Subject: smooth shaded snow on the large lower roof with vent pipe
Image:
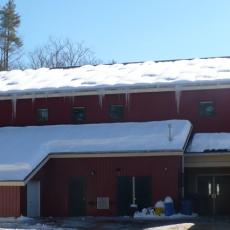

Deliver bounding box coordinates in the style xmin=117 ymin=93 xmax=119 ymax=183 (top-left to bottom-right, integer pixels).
xmin=0 ymin=120 xmax=191 ymax=181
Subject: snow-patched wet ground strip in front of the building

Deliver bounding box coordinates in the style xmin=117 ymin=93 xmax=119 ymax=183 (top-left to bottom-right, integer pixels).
xmin=3 ymin=216 xmax=230 ymax=230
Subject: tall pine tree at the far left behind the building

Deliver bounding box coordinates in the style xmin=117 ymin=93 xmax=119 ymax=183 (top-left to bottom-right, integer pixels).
xmin=0 ymin=0 xmax=22 ymax=70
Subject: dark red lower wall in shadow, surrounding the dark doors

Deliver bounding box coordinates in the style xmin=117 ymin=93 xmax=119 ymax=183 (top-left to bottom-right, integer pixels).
xmin=34 ymin=156 xmax=180 ymax=216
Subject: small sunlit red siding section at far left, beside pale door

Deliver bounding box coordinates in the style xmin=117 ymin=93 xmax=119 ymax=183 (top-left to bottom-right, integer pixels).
xmin=0 ymin=186 xmax=23 ymax=217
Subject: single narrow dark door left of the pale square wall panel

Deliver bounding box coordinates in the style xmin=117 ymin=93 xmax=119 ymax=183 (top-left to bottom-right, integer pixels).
xmin=69 ymin=177 xmax=86 ymax=216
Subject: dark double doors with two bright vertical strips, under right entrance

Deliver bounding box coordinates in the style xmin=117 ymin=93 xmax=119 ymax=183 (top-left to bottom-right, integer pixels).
xmin=197 ymin=175 xmax=230 ymax=215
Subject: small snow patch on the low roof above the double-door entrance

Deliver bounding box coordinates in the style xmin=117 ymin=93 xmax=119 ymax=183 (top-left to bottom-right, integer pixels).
xmin=186 ymin=133 xmax=230 ymax=153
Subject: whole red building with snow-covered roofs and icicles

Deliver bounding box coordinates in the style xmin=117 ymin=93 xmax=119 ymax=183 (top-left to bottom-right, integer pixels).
xmin=0 ymin=58 xmax=230 ymax=216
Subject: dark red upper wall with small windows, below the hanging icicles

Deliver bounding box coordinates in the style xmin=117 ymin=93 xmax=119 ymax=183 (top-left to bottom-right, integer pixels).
xmin=0 ymin=89 xmax=230 ymax=132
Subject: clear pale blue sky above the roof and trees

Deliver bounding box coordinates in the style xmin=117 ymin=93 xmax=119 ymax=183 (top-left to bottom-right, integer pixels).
xmin=0 ymin=0 xmax=230 ymax=62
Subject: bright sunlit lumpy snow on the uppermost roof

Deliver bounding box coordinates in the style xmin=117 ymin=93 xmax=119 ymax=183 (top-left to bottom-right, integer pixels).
xmin=0 ymin=58 xmax=230 ymax=94
